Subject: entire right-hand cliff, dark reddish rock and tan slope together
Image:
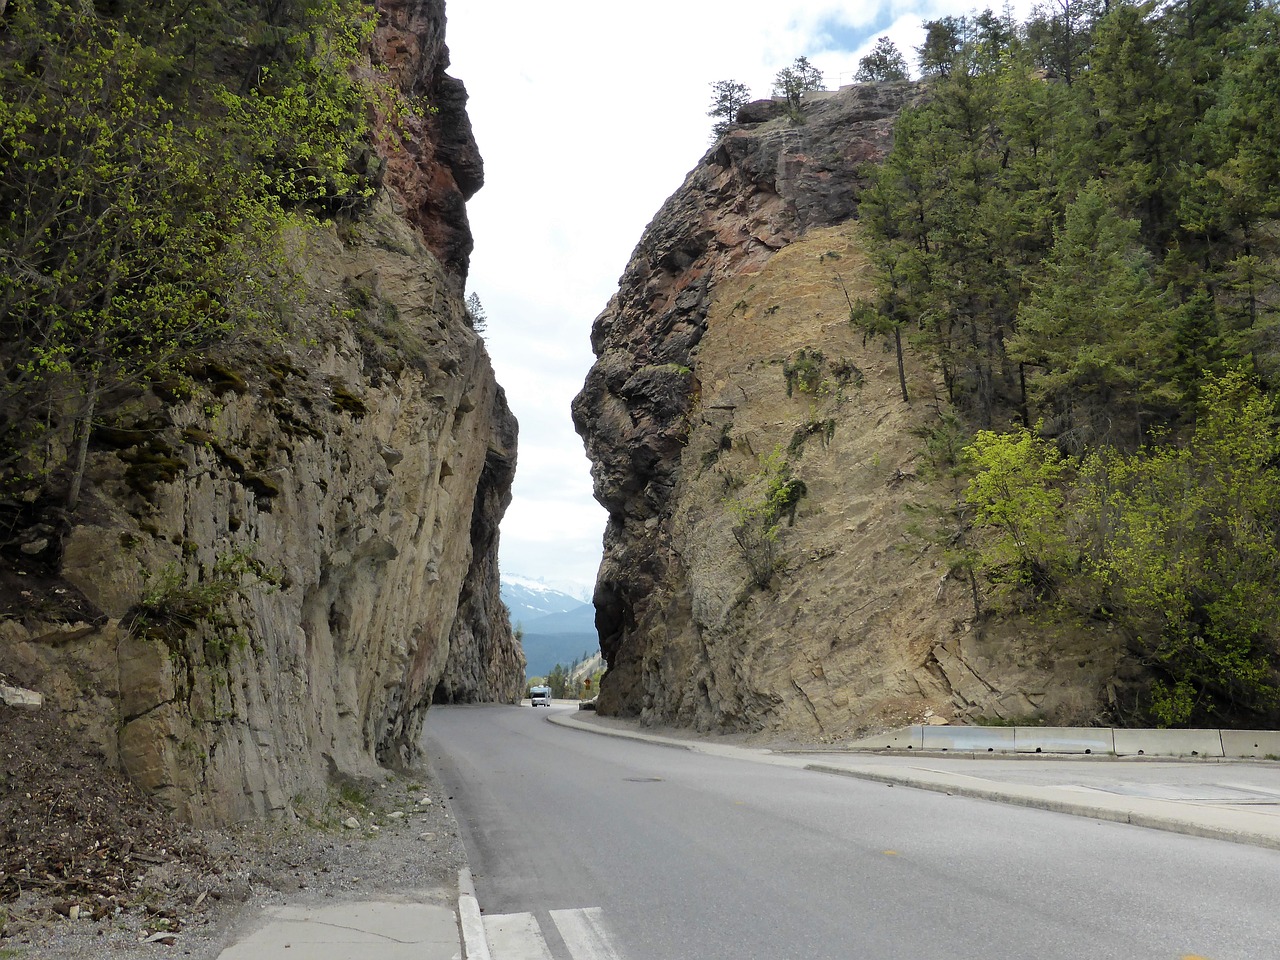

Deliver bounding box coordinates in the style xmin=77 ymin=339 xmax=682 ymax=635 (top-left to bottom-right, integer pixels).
xmin=573 ymin=83 xmax=1115 ymax=737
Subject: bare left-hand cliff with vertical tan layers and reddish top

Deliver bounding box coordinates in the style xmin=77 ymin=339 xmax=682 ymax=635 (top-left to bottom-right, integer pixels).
xmin=0 ymin=0 xmax=524 ymax=823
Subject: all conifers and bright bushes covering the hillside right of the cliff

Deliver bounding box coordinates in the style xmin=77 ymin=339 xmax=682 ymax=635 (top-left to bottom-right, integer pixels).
xmin=851 ymin=0 xmax=1280 ymax=726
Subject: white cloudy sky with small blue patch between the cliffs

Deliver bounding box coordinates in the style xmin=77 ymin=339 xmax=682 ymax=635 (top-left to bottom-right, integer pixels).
xmin=447 ymin=0 xmax=1027 ymax=595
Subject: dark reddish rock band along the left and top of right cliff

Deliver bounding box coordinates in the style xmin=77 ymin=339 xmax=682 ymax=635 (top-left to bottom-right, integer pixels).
xmin=573 ymin=83 xmax=918 ymax=721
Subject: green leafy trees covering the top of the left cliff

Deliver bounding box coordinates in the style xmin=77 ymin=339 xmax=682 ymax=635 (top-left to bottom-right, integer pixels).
xmin=0 ymin=0 xmax=376 ymax=506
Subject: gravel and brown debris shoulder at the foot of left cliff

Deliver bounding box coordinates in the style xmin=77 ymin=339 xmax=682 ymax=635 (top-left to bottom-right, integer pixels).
xmin=0 ymin=705 xmax=466 ymax=960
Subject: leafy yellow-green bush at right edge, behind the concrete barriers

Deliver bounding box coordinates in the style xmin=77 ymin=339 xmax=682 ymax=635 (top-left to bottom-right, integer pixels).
xmin=1087 ymin=372 xmax=1280 ymax=719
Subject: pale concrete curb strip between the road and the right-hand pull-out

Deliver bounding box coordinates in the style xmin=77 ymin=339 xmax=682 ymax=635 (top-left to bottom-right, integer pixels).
xmin=804 ymin=763 xmax=1280 ymax=850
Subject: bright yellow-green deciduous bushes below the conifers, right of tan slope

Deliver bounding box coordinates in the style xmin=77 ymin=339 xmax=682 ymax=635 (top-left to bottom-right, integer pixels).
xmin=968 ymin=371 xmax=1280 ymax=724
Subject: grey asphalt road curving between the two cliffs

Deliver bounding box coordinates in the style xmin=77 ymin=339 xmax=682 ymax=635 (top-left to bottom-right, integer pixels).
xmin=425 ymin=707 xmax=1280 ymax=960
